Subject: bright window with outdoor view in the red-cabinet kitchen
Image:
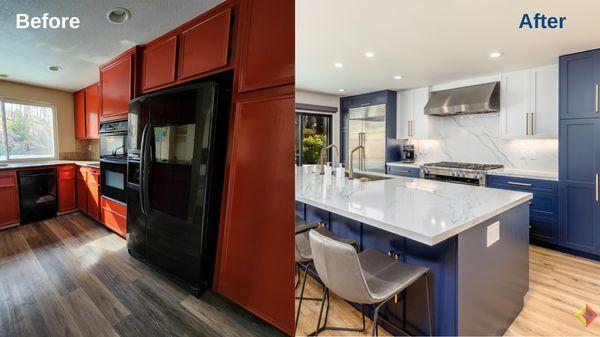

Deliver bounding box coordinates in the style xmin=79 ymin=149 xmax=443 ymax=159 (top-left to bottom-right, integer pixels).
xmin=0 ymin=100 xmax=55 ymax=160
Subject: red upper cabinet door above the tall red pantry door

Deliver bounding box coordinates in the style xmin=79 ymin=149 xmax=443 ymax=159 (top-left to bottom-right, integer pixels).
xmin=239 ymin=0 xmax=295 ymax=91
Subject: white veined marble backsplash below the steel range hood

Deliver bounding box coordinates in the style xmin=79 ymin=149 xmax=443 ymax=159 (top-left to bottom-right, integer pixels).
xmin=409 ymin=113 xmax=558 ymax=172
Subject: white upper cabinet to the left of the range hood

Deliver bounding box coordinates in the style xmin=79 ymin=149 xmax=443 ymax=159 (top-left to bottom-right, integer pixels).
xmin=396 ymin=87 xmax=430 ymax=139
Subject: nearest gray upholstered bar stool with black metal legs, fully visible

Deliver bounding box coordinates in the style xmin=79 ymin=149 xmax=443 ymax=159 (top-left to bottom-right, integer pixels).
xmin=309 ymin=230 xmax=433 ymax=336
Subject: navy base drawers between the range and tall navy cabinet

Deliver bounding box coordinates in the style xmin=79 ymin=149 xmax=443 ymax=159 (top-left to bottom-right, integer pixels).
xmin=486 ymin=175 xmax=559 ymax=244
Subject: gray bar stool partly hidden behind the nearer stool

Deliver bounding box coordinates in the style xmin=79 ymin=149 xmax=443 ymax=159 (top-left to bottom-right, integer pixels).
xmin=294 ymin=216 xmax=364 ymax=329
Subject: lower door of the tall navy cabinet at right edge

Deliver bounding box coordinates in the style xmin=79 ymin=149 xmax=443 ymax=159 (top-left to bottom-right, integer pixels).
xmin=559 ymin=118 xmax=600 ymax=254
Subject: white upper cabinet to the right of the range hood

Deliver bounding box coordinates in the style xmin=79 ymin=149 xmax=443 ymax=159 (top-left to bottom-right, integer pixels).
xmin=500 ymin=65 xmax=558 ymax=139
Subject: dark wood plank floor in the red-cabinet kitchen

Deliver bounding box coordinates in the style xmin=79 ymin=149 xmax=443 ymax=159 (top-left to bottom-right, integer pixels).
xmin=0 ymin=213 xmax=283 ymax=337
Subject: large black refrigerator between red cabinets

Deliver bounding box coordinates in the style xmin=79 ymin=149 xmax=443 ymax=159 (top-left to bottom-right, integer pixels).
xmin=127 ymin=79 xmax=231 ymax=294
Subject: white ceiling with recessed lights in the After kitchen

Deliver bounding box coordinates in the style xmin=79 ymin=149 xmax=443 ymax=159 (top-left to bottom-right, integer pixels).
xmin=296 ymin=0 xmax=600 ymax=95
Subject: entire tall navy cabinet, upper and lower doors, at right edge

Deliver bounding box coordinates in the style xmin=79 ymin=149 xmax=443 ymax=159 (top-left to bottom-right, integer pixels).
xmin=558 ymin=49 xmax=600 ymax=255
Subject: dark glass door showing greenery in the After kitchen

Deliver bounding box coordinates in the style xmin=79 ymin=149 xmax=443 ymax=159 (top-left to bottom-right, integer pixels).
xmin=296 ymin=112 xmax=332 ymax=165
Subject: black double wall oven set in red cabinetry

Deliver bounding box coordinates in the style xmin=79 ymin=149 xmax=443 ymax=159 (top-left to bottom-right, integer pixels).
xmin=100 ymin=120 xmax=128 ymax=203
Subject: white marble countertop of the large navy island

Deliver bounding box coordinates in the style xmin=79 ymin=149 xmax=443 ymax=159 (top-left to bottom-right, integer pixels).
xmin=296 ymin=167 xmax=532 ymax=246
